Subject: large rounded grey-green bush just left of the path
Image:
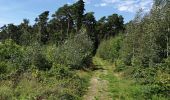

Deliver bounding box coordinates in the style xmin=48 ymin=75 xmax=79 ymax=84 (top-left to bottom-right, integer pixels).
xmin=54 ymin=30 xmax=93 ymax=69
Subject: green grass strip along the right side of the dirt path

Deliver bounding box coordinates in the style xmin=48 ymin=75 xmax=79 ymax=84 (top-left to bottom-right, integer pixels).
xmin=93 ymin=57 xmax=167 ymax=100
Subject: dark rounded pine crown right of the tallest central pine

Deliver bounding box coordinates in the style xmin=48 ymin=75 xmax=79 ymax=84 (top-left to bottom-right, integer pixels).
xmin=97 ymin=14 xmax=124 ymax=40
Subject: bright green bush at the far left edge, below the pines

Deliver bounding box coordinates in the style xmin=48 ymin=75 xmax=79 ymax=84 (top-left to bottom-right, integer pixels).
xmin=0 ymin=40 xmax=23 ymax=74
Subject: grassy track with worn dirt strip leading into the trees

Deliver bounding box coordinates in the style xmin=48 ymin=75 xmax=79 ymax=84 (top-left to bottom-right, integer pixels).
xmin=83 ymin=57 xmax=146 ymax=100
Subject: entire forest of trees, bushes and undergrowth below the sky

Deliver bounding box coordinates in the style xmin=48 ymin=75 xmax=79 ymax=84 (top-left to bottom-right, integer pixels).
xmin=0 ymin=0 xmax=170 ymax=100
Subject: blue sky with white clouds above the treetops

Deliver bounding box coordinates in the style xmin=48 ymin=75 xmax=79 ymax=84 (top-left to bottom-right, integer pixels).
xmin=0 ymin=0 xmax=153 ymax=26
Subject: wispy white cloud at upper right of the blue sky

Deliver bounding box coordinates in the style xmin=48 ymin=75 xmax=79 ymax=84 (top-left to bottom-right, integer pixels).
xmin=95 ymin=0 xmax=153 ymax=13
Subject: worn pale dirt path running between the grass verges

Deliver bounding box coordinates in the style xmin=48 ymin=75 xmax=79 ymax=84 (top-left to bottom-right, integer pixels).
xmin=83 ymin=57 xmax=112 ymax=100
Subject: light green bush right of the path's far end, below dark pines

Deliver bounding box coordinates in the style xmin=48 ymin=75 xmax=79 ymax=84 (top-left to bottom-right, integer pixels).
xmin=97 ymin=36 xmax=123 ymax=62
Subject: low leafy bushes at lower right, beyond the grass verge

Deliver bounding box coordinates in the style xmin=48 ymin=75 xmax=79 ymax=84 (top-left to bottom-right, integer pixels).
xmin=125 ymin=64 xmax=170 ymax=99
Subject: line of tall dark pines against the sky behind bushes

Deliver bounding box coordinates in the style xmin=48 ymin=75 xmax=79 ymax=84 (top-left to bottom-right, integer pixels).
xmin=0 ymin=0 xmax=124 ymax=47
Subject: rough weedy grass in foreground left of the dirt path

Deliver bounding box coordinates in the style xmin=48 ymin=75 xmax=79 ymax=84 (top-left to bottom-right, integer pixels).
xmin=0 ymin=71 xmax=91 ymax=100
